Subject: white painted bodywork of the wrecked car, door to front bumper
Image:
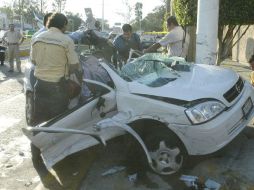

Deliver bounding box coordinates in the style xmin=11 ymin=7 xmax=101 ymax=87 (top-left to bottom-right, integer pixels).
xmin=23 ymin=55 xmax=254 ymax=168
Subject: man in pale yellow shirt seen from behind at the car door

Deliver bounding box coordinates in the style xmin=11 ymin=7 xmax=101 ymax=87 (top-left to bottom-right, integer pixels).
xmin=31 ymin=13 xmax=79 ymax=123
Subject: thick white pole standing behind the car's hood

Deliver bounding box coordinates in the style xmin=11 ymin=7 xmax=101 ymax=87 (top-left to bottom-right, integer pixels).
xmin=196 ymin=0 xmax=219 ymax=65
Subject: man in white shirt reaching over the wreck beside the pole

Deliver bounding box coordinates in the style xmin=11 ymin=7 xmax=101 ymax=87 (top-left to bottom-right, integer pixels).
xmin=144 ymin=16 xmax=190 ymax=58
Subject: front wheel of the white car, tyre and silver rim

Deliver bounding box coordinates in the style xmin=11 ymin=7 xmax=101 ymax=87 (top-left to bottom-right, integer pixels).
xmin=145 ymin=127 xmax=187 ymax=175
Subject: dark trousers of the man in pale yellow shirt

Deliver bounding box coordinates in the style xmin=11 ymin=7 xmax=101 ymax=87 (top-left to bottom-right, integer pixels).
xmin=34 ymin=79 xmax=69 ymax=123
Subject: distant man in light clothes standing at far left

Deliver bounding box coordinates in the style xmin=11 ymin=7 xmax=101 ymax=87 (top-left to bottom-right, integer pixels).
xmin=3 ymin=24 xmax=24 ymax=73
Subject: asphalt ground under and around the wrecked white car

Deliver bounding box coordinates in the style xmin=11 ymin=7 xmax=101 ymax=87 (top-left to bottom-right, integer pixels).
xmin=0 ymin=60 xmax=254 ymax=190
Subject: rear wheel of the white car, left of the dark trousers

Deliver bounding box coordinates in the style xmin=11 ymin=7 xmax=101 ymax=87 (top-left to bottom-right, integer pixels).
xmin=26 ymin=92 xmax=35 ymax=126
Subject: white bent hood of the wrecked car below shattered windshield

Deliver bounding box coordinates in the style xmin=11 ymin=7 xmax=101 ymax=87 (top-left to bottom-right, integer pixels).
xmin=129 ymin=64 xmax=239 ymax=102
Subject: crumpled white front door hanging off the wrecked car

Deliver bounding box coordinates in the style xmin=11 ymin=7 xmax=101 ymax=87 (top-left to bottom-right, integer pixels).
xmin=26 ymin=79 xmax=117 ymax=168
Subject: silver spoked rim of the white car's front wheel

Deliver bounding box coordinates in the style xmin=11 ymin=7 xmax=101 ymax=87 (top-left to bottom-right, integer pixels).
xmin=149 ymin=141 xmax=183 ymax=175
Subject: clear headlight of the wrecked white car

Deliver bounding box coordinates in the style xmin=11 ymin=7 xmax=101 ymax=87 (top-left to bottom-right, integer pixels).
xmin=185 ymin=100 xmax=226 ymax=124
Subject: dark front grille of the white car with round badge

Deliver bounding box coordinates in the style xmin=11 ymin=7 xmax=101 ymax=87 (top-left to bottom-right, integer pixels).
xmin=223 ymin=77 xmax=244 ymax=103
